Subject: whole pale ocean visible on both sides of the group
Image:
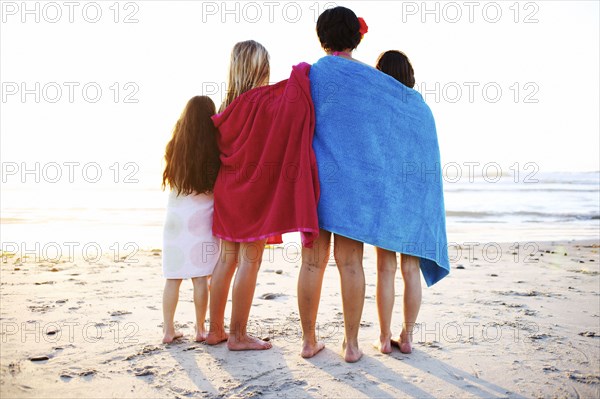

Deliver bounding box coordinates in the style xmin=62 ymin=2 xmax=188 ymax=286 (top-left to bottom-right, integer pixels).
xmin=0 ymin=172 xmax=600 ymax=256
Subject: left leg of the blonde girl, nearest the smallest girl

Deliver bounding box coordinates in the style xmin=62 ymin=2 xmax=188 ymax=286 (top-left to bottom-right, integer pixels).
xmin=206 ymin=240 xmax=240 ymax=345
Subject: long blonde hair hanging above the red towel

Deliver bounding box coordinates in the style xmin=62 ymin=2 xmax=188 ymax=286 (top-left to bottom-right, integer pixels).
xmin=219 ymin=40 xmax=271 ymax=112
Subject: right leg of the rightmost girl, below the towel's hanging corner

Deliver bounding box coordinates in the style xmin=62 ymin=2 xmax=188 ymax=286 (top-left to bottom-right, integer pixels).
xmin=400 ymin=254 xmax=421 ymax=353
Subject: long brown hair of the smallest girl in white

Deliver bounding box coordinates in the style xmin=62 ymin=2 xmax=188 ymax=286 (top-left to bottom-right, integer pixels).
xmin=162 ymin=96 xmax=220 ymax=195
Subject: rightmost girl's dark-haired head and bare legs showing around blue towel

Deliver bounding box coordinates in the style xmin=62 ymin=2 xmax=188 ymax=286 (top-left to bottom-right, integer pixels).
xmin=376 ymin=50 xmax=421 ymax=353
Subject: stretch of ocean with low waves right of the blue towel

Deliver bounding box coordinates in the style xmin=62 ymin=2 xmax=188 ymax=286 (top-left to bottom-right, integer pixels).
xmin=444 ymin=172 xmax=600 ymax=242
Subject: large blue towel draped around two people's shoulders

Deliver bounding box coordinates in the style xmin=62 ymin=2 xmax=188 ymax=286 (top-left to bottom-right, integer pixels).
xmin=310 ymin=56 xmax=450 ymax=286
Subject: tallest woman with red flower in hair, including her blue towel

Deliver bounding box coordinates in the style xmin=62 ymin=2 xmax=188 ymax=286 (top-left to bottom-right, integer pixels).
xmin=298 ymin=7 xmax=450 ymax=362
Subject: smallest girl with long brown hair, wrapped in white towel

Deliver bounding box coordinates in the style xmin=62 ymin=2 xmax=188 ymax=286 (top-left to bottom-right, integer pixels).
xmin=162 ymin=96 xmax=219 ymax=343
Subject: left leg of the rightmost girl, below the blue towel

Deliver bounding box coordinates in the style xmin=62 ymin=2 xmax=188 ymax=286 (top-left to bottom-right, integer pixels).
xmin=376 ymin=248 xmax=398 ymax=353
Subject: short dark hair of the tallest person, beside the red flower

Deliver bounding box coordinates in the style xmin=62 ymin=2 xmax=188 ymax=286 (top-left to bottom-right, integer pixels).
xmin=317 ymin=7 xmax=361 ymax=51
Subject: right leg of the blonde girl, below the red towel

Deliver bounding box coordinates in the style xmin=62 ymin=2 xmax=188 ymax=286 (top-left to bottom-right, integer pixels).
xmin=227 ymin=240 xmax=272 ymax=350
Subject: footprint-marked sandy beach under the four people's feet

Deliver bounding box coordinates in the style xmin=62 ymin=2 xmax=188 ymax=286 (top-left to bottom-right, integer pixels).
xmin=0 ymin=241 xmax=600 ymax=398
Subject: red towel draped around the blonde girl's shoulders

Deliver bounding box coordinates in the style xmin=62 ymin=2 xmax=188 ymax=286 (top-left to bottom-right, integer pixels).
xmin=213 ymin=63 xmax=319 ymax=247
